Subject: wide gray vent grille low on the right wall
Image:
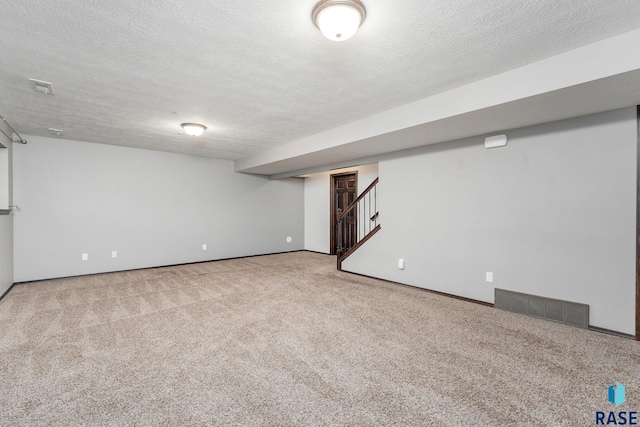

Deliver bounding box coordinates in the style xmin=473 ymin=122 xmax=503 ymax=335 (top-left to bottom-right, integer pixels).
xmin=494 ymin=288 xmax=589 ymax=329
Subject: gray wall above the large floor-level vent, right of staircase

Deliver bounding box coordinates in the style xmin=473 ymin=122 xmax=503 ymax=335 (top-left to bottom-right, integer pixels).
xmin=343 ymin=108 xmax=637 ymax=334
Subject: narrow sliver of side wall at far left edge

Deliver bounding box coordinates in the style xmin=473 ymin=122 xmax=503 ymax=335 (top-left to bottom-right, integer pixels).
xmin=0 ymin=120 xmax=13 ymax=295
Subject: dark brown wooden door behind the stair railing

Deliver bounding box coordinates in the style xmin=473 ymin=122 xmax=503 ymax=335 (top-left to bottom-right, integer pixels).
xmin=330 ymin=173 xmax=358 ymax=255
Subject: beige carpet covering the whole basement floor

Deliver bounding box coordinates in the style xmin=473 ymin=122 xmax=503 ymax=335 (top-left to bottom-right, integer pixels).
xmin=0 ymin=252 xmax=640 ymax=426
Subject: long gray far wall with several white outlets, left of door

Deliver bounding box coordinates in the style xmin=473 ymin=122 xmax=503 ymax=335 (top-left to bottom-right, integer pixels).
xmin=14 ymin=136 xmax=304 ymax=282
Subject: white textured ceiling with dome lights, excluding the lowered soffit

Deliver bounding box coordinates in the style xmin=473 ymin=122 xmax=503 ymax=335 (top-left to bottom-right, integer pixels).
xmin=0 ymin=0 xmax=640 ymax=160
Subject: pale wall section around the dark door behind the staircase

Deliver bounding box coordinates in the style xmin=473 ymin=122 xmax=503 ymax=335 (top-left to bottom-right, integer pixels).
xmin=304 ymin=163 xmax=378 ymax=254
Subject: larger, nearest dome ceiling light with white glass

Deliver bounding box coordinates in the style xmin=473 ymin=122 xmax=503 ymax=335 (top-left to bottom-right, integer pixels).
xmin=311 ymin=0 xmax=367 ymax=41
